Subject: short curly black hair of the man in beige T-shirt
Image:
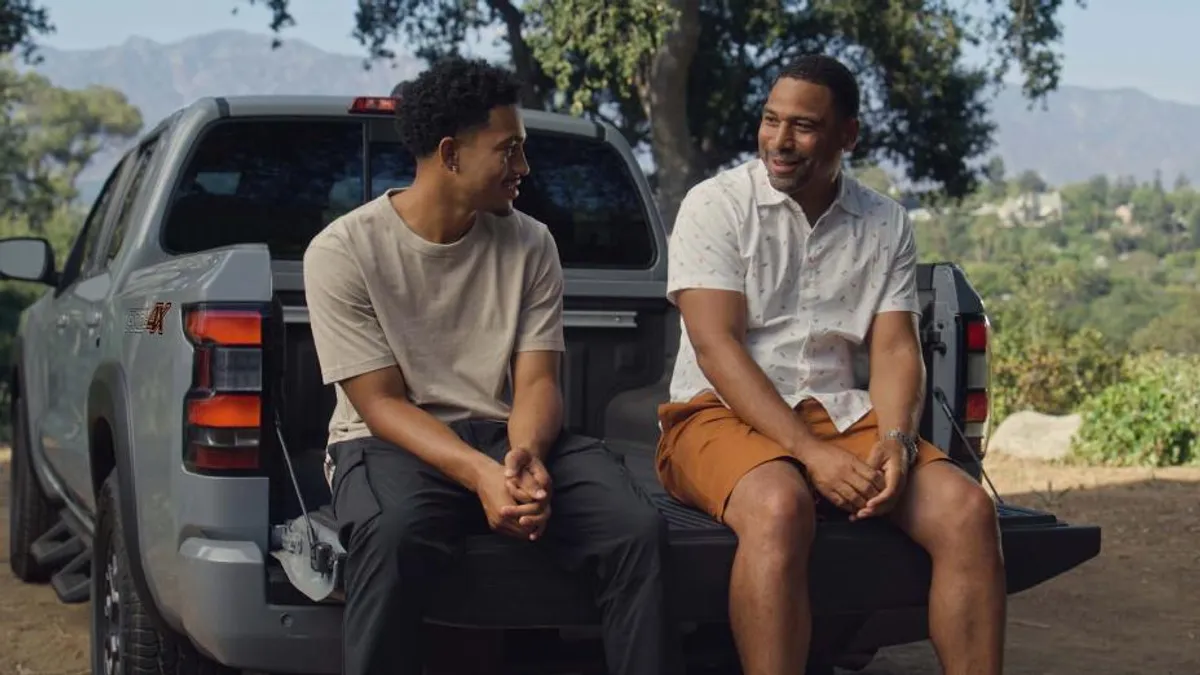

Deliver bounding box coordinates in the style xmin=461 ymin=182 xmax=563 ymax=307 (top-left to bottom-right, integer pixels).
xmin=392 ymin=56 xmax=521 ymax=157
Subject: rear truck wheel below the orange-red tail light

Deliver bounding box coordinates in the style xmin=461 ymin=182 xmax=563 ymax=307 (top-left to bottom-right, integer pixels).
xmin=91 ymin=472 xmax=235 ymax=675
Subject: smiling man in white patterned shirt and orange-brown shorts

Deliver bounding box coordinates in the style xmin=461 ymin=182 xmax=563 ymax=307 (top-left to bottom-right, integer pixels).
xmin=658 ymin=56 xmax=1004 ymax=675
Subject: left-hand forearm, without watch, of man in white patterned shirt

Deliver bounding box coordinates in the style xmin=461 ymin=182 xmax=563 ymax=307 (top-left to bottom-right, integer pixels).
xmin=696 ymin=338 xmax=815 ymax=461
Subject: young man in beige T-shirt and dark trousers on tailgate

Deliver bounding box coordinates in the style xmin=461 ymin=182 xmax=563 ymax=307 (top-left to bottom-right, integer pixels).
xmin=305 ymin=59 xmax=668 ymax=675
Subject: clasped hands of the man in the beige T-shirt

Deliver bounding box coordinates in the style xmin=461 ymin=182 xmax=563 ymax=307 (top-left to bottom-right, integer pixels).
xmin=479 ymin=448 xmax=551 ymax=542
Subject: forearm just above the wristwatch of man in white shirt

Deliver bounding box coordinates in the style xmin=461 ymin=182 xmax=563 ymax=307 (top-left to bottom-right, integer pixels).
xmin=869 ymin=347 xmax=925 ymax=434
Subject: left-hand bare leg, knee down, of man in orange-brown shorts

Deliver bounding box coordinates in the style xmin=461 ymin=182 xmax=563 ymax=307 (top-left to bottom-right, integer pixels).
xmin=725 ymin=460 xmax=816 ymax=675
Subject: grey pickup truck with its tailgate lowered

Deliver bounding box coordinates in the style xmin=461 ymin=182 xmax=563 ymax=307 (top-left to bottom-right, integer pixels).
xmin=0 ymin=96 xmax=1100 ymax=674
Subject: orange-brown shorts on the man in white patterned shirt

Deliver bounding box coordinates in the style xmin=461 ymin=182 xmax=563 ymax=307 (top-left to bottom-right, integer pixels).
xmin=655 ymin=392 xmax=949 ymax=522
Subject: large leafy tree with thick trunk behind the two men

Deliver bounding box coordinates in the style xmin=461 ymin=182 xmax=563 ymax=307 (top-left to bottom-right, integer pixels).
xmin=0 ymin=0 xmax=1084 ymax=221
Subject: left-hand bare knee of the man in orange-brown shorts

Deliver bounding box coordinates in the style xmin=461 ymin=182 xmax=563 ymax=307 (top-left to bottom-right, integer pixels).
xmin=725 ymin=460 xmax=816 ymax=551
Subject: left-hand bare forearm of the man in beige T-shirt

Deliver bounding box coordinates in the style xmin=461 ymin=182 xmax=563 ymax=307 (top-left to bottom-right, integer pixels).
xmin=368 ymin=399 xmax=498 ymax=492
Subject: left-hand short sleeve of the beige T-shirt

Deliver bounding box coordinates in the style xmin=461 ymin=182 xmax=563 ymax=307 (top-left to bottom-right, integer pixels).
xmin=304 ymin=239 xmax=396 ymax=384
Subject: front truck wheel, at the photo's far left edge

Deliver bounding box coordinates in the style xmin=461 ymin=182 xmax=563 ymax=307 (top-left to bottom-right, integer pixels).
xmin=8 ymin=392 xmax=55 ymax=584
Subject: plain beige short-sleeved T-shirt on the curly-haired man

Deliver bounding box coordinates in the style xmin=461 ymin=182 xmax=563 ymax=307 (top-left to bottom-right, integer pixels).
xmin=304 ymin=190 xmax=565 ymax=444
